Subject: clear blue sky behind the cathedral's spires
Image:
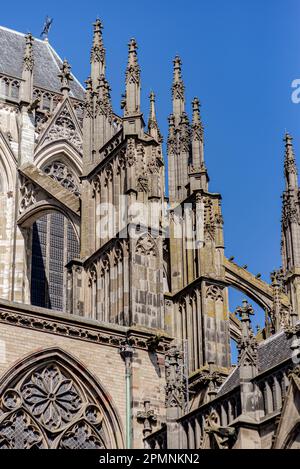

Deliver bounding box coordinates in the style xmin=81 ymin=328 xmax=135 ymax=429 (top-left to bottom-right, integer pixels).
xmin=1 ymin=0 xmax=300 ymax=334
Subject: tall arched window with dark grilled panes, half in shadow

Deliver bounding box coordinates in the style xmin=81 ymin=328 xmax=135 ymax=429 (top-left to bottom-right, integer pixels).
xmin=31 ymin=212 xmax=79 ymax=311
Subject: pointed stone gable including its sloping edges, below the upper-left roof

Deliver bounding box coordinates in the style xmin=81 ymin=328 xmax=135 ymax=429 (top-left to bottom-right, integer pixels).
xmin=35 ymin=98 xmax=82 ymax=154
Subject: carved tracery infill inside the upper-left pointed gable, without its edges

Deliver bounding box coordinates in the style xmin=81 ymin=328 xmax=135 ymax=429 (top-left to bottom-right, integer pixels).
xmin=43 ymin=107 xmax=82 ymax=153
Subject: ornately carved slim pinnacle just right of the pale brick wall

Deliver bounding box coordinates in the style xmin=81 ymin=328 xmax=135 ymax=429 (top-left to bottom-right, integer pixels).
xmin=165 ymin=346 xmax=186 ymax=409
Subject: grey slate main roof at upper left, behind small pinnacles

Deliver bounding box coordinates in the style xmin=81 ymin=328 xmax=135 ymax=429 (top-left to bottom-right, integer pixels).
xmin=0 ymin=26 xmax=84 ymax=99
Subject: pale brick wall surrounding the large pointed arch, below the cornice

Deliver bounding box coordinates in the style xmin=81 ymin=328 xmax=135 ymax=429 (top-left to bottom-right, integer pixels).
xmin=0 ymin=306 xmax=165 ymax=448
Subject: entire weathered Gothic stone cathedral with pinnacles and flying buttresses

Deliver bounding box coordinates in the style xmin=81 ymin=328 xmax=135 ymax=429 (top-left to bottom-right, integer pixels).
xmin=0 ymin=20 xmax=300 ymax=449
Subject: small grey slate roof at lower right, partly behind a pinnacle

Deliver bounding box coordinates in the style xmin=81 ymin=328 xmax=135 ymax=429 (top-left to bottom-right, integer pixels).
xmin=217 ymin=331 xmax=292 ymax=397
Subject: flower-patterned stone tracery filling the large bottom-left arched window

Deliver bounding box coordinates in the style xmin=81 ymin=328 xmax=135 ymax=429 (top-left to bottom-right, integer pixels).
xmin=0 ymin=361 xmax=106 ymax=449
